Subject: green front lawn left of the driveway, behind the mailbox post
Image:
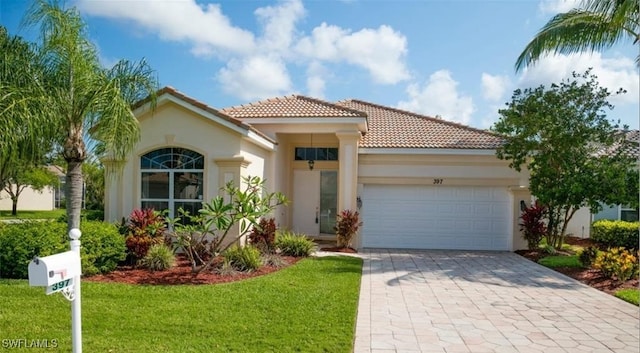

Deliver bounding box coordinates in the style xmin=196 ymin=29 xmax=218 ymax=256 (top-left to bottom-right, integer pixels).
xmin=0 ymin=256 xmax=362 ymax=353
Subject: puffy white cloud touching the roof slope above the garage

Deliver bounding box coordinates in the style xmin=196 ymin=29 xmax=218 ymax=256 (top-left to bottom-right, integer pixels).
xmin=398 ymin=70 xmax=475 ymax=124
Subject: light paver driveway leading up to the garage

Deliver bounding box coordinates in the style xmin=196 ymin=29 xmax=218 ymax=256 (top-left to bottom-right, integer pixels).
xmin=355 ymin=250 xmax=640 ymax=353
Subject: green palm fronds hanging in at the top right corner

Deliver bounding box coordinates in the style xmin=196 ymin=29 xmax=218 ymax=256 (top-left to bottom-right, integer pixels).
xmin=515 ymin=0 xmax=640 ymax=71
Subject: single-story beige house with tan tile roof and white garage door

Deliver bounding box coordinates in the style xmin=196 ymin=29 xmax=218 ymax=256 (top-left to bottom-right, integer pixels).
xmin=103 ymin=87 xmax=531 ymax=250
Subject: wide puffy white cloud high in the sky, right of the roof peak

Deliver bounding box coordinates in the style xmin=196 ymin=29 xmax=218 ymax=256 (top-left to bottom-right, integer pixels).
xmin=296 ymin=23 xmax=410 ymax=84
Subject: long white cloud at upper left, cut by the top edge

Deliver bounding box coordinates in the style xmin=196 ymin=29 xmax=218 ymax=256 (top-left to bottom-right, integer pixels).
xmin=77 ymin=0 xmax=255 ymax=55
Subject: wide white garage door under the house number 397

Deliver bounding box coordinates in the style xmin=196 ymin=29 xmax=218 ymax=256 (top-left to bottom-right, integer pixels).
xmin=361 ymin=185 xmax=511 ymax=250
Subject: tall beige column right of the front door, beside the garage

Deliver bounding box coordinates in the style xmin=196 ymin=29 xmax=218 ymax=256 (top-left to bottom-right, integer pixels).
xmin=336 ymin=131 xmax=361 ymax=212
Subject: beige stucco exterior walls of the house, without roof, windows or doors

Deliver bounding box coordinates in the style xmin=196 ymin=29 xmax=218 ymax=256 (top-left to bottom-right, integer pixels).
xmin=104 ymin=89 xmax=531 ymax=249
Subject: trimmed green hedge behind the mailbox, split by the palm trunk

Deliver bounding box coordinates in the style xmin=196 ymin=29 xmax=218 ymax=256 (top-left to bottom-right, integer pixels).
xmin=0 ymin=221 xmax=125 ymax=278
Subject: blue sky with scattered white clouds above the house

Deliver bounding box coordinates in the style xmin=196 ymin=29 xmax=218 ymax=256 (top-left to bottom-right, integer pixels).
xmin=0 ymin=0 xmax=640 ymax=129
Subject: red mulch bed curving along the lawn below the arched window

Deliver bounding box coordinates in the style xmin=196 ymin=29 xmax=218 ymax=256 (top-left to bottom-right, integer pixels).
xmin=83 ymin=256 xmax=301 ymax=285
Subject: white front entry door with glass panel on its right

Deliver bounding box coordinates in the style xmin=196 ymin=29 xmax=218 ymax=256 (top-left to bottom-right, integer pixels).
xmin=292 ymin=170 xmax=338 ymax=236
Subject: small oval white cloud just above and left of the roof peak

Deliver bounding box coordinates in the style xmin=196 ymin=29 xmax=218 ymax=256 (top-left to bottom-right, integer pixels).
xmin=217 ymin=56 xmax=291 ymax=100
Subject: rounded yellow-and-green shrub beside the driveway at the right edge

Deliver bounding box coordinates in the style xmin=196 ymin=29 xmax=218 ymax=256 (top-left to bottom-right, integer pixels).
xmin=593 ymin=247 xmax=638 ymax=281
